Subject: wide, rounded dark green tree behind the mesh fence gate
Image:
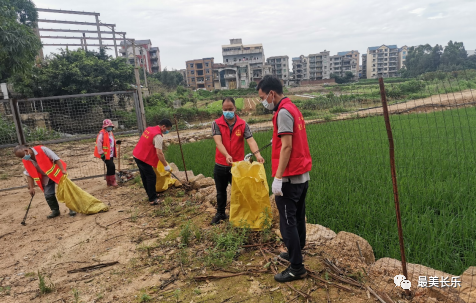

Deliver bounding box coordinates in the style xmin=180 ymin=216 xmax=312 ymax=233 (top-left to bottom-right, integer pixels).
xmin=12 ymin=49 xmax=134 ymax=97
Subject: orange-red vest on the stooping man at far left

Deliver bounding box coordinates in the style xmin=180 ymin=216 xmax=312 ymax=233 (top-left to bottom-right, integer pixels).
xmin=23 ymin=145 xmax=66 ymax=191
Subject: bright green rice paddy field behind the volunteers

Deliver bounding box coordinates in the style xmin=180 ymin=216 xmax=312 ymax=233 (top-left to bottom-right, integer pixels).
xmin=166 ymin=107 xmax=476 ymax=275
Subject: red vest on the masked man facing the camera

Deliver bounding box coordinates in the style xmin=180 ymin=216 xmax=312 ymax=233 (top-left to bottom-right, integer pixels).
xmin=215 ymin=116 xmax=246 ymax=166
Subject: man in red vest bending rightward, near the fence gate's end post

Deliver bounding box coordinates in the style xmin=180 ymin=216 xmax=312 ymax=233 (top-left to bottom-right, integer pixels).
xmin=132 ymin=119 xmax=172 ymax=205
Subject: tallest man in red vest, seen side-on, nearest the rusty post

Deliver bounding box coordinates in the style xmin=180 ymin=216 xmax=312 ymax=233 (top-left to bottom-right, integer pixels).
xmin=257 ymin=75 xmax=312 ymax=282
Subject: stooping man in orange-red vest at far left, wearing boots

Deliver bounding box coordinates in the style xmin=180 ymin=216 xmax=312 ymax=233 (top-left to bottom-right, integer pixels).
xmin=13 ymin=145 xmax=76 ymax=219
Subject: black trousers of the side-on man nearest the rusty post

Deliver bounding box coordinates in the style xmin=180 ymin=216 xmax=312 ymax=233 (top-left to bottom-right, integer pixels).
xmin=275 ymin=182 xmax=309 ymax=268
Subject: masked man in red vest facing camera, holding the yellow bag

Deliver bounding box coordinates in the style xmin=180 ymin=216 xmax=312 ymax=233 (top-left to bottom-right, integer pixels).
xmin=211 ymin=97 xmax=264 ymax=224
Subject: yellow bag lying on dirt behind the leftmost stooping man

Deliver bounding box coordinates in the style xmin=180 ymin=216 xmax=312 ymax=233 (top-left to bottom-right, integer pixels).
xmin=56 ymin=175 xmax=109 ymax=215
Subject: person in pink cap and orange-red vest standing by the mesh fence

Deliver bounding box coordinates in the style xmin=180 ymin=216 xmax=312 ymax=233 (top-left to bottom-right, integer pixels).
xmin=94 ymin=119 xmax=120 ymax=187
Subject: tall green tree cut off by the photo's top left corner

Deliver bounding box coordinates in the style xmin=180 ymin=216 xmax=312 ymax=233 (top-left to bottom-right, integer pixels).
xmin=0 ymin=0 xmax=41 ymax=82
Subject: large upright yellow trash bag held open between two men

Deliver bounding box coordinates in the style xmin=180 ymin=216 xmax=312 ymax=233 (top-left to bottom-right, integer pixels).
xmin=230 ymin=161 xmax=272 ymax=230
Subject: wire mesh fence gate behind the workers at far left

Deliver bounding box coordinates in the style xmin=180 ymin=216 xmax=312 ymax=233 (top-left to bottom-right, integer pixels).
xmin=0 ymin=91 xmax=141 ymax=190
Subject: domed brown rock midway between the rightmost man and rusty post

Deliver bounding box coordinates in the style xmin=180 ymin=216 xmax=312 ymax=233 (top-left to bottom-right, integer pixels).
xmin=326 ymin=231 xmax=375 ymax=268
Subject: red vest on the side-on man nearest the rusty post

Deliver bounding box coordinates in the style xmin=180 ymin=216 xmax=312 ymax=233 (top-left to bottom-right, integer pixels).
xmin=271 ymin=98 xmax=312 ymax=177
